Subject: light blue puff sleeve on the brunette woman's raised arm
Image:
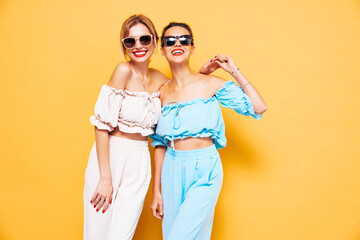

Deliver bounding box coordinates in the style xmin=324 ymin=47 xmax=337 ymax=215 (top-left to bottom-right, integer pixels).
xmin=215 ymin=81 xmax=262 ymax=120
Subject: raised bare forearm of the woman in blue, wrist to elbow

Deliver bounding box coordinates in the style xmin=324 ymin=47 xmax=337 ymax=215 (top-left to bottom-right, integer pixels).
xmin=230 ymin=67 xmax=267 ymax=113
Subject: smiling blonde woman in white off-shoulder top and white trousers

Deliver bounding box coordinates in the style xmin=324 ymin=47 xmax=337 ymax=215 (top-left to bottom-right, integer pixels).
xmin=84 ymin=15 xmax=167 ymax=240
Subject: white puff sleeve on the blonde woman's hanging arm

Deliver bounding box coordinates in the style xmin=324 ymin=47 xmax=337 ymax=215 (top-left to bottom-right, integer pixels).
xmin=90 ymin=85 xmax=123 ymax=132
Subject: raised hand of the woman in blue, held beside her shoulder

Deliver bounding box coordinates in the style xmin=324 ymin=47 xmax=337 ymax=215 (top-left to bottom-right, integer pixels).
xmin=200 ymin=54 xmax=238 ymax=77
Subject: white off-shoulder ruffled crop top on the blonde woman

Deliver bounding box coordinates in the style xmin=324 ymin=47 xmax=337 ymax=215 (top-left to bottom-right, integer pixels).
xmin=90 ymin=85 xmax=161 ymax=136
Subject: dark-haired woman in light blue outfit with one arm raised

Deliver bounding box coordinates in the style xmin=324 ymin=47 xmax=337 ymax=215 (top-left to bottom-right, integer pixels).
xmin=151 ymin=22 xmax=266 ymax=240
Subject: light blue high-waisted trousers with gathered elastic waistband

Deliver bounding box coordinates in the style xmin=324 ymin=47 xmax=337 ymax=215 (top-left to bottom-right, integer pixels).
xmin=161 ymin=145 xmax=223 ymax=240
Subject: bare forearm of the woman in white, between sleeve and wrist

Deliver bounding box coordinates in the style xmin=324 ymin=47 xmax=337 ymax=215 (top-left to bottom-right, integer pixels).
xmin=95 ymin=127 xmax=111 ymax=180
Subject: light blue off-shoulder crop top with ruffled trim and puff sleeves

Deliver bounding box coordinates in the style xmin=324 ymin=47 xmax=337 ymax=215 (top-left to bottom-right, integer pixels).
xmin=150 ymin=81 xmax=262 ymax=149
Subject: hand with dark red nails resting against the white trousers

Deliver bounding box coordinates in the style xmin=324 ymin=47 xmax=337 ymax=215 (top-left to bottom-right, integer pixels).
xmin=90 ymin=179 xmax=113 ymax=213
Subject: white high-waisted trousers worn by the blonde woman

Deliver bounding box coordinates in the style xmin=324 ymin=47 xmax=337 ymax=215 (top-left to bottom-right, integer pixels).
xmin=84 ymin=136 xmax=151 ymax=240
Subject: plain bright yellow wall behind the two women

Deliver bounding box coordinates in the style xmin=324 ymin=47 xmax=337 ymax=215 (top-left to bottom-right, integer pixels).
xmin=0 ymin=0 xmax=360 ymax=240
